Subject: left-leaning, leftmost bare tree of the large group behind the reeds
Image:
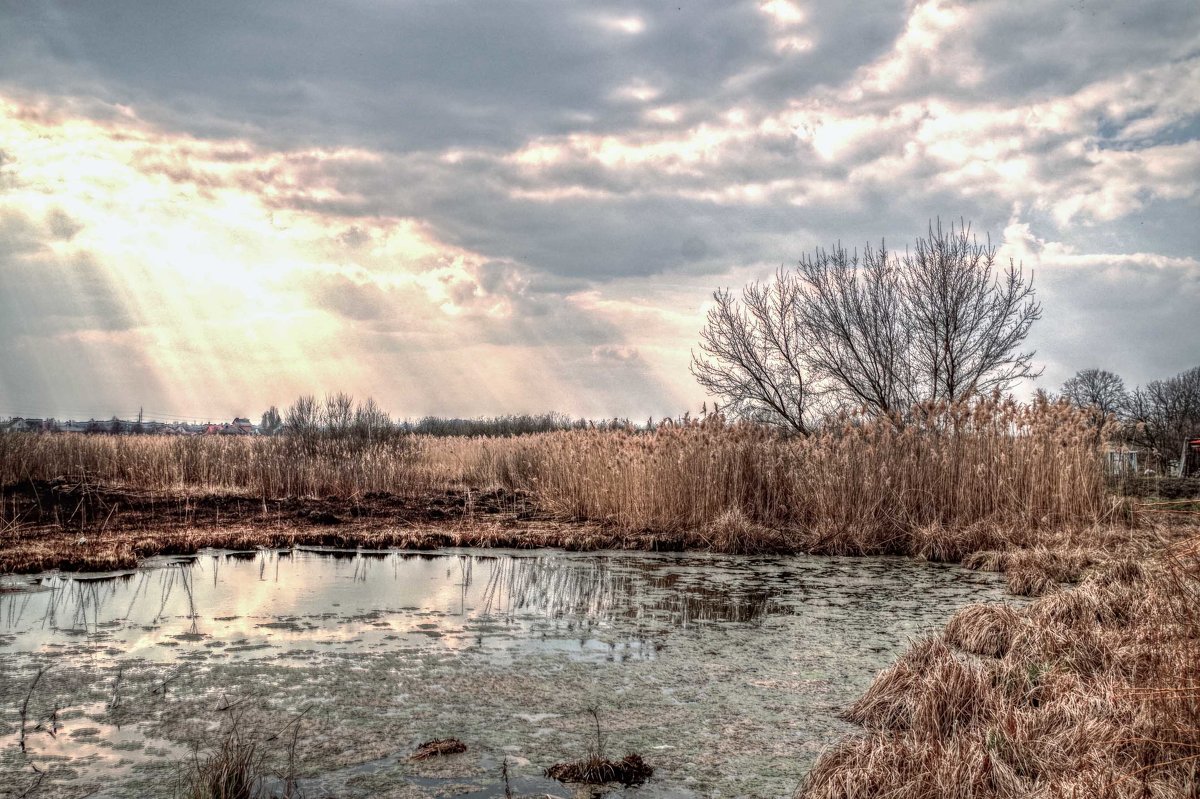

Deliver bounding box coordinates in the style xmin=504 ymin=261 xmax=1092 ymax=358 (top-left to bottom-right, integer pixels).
xmin=691 ymin=269 xmax=811 ymax=433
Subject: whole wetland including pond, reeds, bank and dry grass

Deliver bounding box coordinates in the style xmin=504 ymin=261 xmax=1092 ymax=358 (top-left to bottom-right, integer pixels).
xmin=0 ymin=400 xmax=1200 ymax=799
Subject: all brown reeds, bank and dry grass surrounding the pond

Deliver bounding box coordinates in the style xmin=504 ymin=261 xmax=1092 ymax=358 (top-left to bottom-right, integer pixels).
xmin=0 ymin=391 xmax=1200 ymax=799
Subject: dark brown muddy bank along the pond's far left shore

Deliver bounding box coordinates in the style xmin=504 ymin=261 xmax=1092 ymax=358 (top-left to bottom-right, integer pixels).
xmin=0 ymin=480 xmax=688 ymax=573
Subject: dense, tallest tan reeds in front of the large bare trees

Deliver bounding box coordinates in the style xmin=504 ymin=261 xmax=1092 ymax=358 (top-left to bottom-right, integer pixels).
xmin=475 ymin=400 xmax=1112 ymax=544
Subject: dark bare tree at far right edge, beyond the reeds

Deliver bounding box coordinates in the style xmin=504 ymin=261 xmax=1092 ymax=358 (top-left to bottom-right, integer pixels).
xmin=1129 ymin=366 xmax=1200 ymax=463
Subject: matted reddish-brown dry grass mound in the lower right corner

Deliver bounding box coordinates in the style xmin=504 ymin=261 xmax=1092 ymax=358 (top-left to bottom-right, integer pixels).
xmin=798 ymin=539 xmax=1200 ymax=799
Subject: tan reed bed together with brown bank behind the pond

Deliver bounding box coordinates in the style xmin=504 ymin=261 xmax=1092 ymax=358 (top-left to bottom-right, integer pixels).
xmin=0 ymin=400 xmax=1174 ymax=575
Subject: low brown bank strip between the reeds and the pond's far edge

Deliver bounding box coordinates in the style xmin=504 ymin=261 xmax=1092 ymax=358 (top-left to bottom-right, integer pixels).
xmin=0 ymin=479 xmax=1182 ymax=583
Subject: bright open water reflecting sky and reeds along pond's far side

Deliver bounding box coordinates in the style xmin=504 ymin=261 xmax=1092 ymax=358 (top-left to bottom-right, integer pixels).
xmin=0 ymin=549 xmax=1008 ymax=660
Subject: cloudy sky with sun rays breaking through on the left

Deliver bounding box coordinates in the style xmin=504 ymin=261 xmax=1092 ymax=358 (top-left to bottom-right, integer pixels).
xmin=0 ymin=0 xmax=1200 ymax=420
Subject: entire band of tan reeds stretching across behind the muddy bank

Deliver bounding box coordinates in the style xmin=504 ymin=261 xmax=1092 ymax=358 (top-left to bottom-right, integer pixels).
xmin=0 ymin=398 xmax=1112 ymax=542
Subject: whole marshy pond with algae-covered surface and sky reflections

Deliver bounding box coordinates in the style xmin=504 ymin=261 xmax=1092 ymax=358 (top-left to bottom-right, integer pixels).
xmin=0 ymin=548 xmax=1007 ymax=799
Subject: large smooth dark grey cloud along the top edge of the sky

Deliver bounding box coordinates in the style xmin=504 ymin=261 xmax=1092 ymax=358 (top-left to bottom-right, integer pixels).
xmin=0 ymin=0 xmax=901 ymax=151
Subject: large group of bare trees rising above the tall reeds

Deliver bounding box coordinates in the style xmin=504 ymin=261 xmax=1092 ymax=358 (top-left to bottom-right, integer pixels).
xmin=692 ymin=222 xmax=1042 ymax=422
